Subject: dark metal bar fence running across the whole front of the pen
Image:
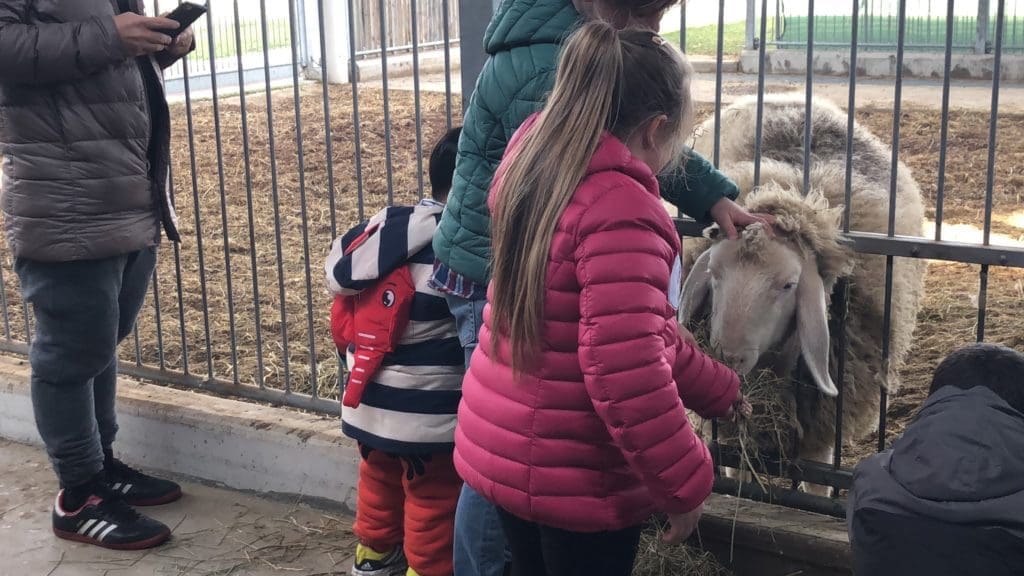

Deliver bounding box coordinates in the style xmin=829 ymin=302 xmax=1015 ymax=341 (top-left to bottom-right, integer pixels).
xmin=0 ymin=0 xmax=1024 ymax=516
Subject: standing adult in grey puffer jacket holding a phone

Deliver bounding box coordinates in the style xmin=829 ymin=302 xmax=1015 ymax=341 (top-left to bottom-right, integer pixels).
xmin=0 ymin=0 xmax=194 ymax=549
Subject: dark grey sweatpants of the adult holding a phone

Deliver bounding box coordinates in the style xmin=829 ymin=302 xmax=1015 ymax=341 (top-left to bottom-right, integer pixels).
xmin=14 ymin=247 xmax=157 ymax=488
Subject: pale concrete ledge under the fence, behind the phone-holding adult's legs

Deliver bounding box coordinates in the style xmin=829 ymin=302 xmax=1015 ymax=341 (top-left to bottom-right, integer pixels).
xmin=0 ymin=357 xmax=358 ymax=510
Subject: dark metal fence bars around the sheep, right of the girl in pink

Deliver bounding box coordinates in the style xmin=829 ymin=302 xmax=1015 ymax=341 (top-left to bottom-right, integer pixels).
xmin=678 ymin=0 xmax=1024 ymax=517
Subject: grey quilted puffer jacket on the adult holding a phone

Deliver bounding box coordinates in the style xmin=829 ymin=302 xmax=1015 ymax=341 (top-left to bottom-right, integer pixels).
xmin=0 ymin=0 xmax=178 ymax=261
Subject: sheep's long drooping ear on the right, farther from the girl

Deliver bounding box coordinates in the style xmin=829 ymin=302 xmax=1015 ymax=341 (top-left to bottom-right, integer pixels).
xmin=797 ymin=260 xmax=839 ymax=397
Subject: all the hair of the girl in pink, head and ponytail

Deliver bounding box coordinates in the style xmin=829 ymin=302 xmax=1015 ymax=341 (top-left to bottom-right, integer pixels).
xmin=490 ymin=20 xmax=692 ymax=373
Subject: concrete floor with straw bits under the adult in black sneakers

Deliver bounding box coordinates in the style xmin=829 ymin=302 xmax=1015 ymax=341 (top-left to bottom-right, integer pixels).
xmin=0 ymin=440 xmax=355 ymax=576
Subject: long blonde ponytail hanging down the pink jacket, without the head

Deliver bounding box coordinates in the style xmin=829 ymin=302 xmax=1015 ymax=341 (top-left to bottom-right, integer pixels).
xmin=490 ymin=23 xmax=623 ymax=370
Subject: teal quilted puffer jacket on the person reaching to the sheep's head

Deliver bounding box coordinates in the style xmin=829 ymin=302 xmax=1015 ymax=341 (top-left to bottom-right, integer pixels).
xmin=433 ymin=0 xmax=738 ymax=284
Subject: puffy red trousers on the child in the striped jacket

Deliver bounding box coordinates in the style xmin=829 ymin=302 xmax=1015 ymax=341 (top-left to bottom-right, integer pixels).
xmin=353 ymin=447 xmax=462 ymax=576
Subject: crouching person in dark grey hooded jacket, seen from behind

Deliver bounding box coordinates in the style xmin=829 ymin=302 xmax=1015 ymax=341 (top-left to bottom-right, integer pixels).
xmin=847 ymin=344 xmax=1024 ymax=576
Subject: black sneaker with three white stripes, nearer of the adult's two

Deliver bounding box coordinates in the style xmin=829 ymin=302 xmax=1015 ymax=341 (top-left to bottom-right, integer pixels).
xmin=53 ymin=486 xmax=171 ymax=550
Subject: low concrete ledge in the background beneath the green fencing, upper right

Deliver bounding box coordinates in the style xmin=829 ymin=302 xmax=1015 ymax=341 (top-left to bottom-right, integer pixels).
xmin=739 ymin=50 xmax=1024 ymax=82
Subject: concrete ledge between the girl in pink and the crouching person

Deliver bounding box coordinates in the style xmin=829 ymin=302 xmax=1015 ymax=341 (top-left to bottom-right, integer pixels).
xmin=694 ymin=494 xmax=853 ymax=576
